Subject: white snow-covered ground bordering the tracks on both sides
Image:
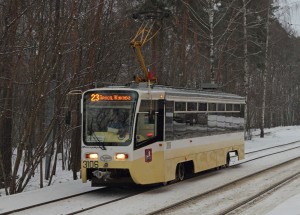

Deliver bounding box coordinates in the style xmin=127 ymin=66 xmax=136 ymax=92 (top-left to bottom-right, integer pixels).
xmin=0 ymin=126 xmax=300 ymax=215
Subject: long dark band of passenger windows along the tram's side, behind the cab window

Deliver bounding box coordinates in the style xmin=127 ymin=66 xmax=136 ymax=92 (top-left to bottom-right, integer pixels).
xmin=165 ymin=101 xmax=244 ymax=141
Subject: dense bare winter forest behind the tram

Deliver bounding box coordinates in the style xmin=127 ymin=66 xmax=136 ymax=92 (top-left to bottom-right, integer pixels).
xmin=0 ymin=0 xmax=300 ymax=194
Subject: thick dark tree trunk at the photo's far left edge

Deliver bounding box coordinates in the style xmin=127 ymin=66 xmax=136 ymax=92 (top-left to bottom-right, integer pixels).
xmin=0 ymin=0 xmax=19 ymax=192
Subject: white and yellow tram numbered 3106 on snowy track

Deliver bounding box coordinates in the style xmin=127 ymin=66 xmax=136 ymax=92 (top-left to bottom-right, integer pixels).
xmin=81 ymin=86 xmax=245 ymax=186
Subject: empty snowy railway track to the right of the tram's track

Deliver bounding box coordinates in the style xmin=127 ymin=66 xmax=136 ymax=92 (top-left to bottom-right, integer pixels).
xmin=149 ymin=156 xmax=300 ymax=215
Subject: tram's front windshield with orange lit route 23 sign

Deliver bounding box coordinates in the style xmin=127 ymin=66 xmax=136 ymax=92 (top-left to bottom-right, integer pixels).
xmin=83 ymin=91 xmax=138 ymax=147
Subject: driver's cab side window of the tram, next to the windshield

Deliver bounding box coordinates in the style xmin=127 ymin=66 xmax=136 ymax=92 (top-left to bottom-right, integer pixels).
xmin=136 ymin=100 xmax=158 ymax=144
